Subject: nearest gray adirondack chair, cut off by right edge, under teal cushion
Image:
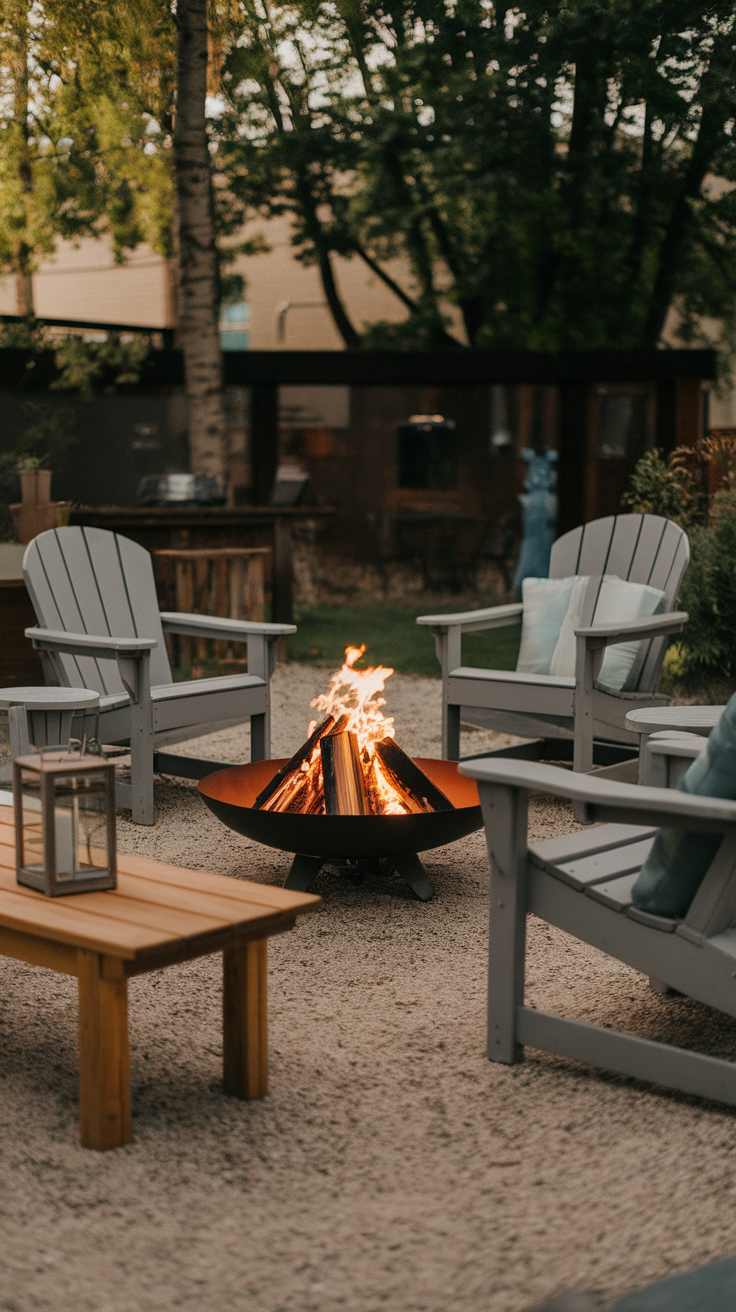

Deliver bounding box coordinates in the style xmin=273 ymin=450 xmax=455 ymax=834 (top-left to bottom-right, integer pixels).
xmin=460 ymin=733 xmax=736 ymax=1106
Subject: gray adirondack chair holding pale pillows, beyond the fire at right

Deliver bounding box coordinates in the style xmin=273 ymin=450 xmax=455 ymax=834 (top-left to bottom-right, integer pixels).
xmin=417 ymin=514 xmax=690 ymax=771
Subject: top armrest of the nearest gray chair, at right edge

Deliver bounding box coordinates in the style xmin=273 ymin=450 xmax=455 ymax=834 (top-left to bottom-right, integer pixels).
xmin=458 ymin=757 xmax=736 ymax=833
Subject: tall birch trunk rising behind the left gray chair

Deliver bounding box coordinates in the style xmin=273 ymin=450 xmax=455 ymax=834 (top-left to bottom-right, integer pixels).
xmin=173 ymin=0 xmax=227 ymax=484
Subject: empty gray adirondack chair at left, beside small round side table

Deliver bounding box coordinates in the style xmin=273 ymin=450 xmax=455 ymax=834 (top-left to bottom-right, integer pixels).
xmin=24 ymin=527 xmax=296 ymax=824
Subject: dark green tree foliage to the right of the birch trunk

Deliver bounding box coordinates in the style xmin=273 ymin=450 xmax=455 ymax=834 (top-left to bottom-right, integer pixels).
xmin=214 ymin=0 xmax=736 ymax=350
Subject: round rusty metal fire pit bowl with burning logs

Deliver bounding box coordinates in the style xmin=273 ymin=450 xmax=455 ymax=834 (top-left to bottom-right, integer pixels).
xmin=198 ymin=648 xmax=483 ymax=901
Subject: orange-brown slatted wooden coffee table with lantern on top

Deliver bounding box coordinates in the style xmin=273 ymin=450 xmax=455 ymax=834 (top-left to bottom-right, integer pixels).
xmin=0 ymin=794 xmax=321 ymax=1149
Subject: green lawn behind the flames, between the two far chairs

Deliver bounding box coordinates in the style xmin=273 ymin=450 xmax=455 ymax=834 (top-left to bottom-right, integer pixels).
xmin=289 ymin=606 xmax=521 ymax=678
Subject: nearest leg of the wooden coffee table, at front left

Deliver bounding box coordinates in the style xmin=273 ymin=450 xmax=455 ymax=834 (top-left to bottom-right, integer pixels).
xmin=76 ymin=949 xmax=133 ymax=1149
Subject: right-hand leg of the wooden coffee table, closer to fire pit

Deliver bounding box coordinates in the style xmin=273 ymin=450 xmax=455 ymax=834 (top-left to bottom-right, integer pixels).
xmin=222 ymin=938 xmax=269 ymax=1098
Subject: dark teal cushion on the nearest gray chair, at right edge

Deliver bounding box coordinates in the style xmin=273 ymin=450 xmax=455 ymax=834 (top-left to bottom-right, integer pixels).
xmin=631 ymin=694 xmax=736 ymax=920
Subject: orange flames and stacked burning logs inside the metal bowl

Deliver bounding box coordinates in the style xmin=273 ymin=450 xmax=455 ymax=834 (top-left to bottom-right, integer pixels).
xmin=256 ymin=644 xmax=451 ymax=815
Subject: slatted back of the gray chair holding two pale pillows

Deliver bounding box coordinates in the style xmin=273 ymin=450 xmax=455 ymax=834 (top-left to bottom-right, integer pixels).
xmin=550 ymin=514 xmax=690 ymax=693
